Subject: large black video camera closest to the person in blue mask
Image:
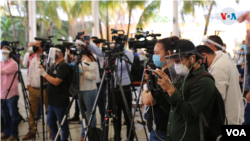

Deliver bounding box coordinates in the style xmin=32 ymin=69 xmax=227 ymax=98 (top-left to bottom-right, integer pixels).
xmin=128 ymin=28 xmax=161 ymax=54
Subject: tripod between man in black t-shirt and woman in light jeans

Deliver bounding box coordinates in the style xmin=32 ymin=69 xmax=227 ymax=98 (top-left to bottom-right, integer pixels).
xmin=54 ymin=55 xmax=89 ymax=141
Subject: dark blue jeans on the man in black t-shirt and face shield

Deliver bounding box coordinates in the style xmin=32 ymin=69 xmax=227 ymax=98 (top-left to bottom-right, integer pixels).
xmin=47 ymin=105 xmax=69 ymax=141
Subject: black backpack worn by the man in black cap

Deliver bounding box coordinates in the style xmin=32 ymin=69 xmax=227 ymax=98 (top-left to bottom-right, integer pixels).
xmin=188 ymin=72 xmax=227 ymax=141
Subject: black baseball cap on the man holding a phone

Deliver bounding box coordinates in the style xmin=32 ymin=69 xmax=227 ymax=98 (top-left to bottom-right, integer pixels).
xmin=170 ymin=40 xmax=205 ymax=59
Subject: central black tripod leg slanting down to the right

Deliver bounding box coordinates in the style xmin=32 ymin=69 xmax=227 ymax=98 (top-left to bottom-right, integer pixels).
xmin=114 ymin=66 xmax=138 ymax=141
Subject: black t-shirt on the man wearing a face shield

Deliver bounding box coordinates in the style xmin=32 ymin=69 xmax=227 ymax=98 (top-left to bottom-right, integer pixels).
xmin=47 ymin=61 xmax=70 ymax=107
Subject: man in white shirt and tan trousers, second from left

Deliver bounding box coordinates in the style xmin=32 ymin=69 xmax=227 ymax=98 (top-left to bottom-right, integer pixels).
xmin=22 ymin=41 xmax=48 ymax=140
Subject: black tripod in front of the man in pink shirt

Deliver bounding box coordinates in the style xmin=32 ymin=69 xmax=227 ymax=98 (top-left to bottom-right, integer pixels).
xmin=0 ymin=52 xmax=39 ymax=141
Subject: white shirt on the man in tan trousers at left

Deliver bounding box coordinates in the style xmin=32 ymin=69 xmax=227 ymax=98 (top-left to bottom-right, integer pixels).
xmin=27 ymin=54 xmax=40 ymax=88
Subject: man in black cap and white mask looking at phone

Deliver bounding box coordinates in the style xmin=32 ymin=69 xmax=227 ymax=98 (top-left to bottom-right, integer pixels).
xmin=147 ymin=40 xmax=216 ymax=141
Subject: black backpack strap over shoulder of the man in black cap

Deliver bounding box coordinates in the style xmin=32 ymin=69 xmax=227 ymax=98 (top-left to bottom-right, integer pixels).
xmin=187 ymin=72 xmax=214 ymax=141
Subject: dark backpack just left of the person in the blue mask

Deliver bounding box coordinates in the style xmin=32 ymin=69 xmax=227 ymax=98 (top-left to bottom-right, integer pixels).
xmin=131 ymin=55 xmax=144 ymax=83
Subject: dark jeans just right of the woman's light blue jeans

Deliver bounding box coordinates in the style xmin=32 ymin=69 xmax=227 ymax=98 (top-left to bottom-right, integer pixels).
xmin=97 ymin=84 xmax=106 ymax=125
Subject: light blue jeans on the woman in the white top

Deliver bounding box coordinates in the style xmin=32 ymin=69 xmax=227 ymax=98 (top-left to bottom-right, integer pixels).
xmin=78 ymin=89 xmax=97 ymax=137
